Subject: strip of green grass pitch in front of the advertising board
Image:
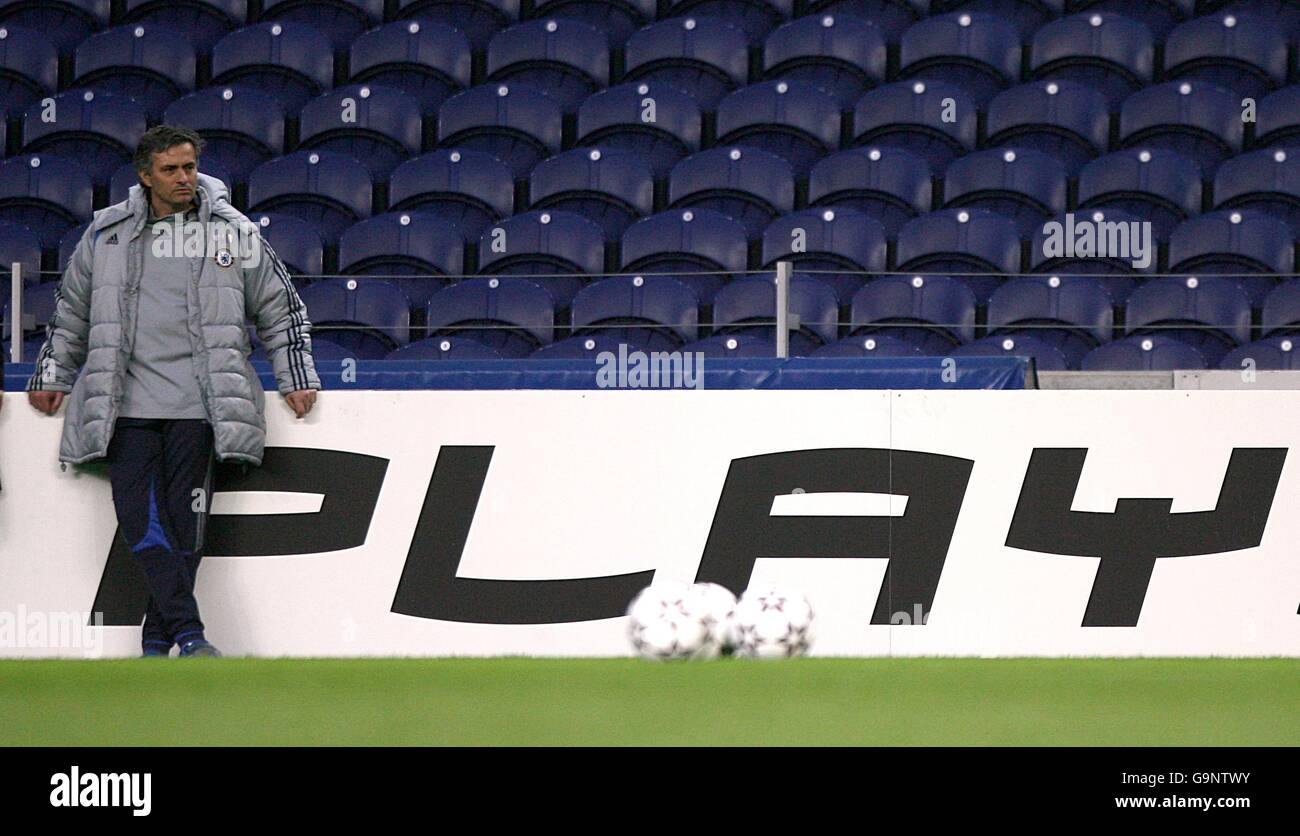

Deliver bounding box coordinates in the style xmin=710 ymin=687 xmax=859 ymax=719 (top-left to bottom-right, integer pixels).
xmin=0 ymin=658 xmax=1300 ymax=746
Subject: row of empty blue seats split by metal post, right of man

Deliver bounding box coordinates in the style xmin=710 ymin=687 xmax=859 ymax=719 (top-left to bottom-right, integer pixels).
xmin=226 ymin=276 xmax=1300 ymax=368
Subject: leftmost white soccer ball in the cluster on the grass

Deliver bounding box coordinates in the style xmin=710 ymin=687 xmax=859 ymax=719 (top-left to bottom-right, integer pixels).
xmin=628 ymin=581 xmax=718 ymax=659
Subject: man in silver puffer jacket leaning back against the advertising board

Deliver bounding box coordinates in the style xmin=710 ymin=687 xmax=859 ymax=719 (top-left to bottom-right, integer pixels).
xmin=27 ymin=125 xmax=320 ymax=657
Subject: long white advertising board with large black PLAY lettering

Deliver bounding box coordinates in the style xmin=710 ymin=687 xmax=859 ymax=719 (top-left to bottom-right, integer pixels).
xmin=0 ymin=390 xmax=1300 ymax=657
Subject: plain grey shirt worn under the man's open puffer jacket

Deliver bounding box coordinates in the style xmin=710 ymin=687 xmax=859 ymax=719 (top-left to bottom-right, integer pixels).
xmin=118 ymin=209 xmax=207 ymax=419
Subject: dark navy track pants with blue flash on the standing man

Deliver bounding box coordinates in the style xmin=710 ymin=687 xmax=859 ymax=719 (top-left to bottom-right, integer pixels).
xmin=108 ymin=417 xmax=212 ymax=647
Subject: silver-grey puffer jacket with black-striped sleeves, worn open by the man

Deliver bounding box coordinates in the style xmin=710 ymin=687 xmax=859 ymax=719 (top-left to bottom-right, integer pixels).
xmin=27 ymin=174 xmax=320 ymax=464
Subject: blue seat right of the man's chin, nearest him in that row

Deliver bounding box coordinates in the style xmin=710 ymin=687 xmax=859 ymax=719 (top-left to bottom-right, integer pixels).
xmin=248 ymin=151 xmax=372 ymax=246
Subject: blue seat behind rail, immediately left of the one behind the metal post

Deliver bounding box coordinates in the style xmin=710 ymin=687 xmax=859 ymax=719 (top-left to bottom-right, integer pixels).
xmin=572 ymin=276 xmax=699 ymax=351
